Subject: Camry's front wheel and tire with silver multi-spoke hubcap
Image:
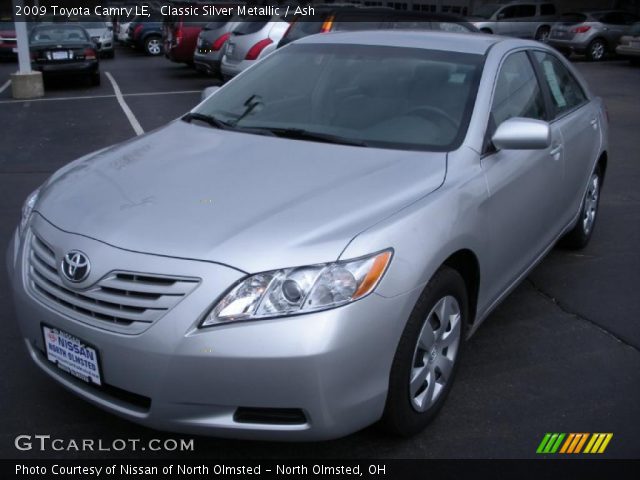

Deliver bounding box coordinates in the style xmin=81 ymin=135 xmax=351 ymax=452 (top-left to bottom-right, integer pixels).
xmin=380 ymin=266 xmax=469 ymax=437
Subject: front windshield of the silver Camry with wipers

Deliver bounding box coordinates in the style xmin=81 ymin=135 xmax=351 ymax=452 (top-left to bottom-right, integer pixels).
xmin=195 ymin=44 xmax=483 ymax=151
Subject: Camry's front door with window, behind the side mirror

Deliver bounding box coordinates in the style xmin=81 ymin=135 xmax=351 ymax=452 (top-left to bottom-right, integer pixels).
xmin=482 ymin=50 xmax=564 ymax=298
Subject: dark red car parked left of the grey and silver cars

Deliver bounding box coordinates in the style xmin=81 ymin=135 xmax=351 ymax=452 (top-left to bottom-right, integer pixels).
xmin=162 ymin=9 xmax=213 ymax=65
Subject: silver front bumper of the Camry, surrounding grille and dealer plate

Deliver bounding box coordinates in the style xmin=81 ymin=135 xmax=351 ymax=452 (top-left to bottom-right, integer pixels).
xmin=7 ymin=214 xmax=418 ymax=440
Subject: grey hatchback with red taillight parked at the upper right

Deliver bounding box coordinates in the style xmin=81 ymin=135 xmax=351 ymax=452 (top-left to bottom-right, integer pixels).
xmin=549 ymin=10 xmax=640 ymax=61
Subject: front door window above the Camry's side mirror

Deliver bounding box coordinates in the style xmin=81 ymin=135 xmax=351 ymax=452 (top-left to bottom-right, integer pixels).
xmin=491 ymin=52 xmax=546 ymax=128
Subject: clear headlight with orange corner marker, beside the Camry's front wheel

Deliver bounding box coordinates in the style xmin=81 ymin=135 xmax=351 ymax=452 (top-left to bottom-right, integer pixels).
xmin=200 ymin=250 xmax=391 ymax=327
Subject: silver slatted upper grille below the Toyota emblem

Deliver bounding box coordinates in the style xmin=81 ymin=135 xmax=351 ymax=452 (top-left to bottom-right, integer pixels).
xmin=28 ymin=234 xmax=199 ymax=333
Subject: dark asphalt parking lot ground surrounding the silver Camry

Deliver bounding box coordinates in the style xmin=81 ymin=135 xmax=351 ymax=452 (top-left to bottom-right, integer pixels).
xmin=0 ymin=49 xmax=640 ymax=459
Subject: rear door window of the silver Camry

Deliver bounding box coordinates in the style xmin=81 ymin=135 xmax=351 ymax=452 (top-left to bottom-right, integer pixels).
xmin=534 ymin=51 xmax=587 ymax=116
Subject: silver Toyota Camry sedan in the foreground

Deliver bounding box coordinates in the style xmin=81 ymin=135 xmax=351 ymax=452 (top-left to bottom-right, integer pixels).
xmin=8 ymin=31 xmax=608 ymax=440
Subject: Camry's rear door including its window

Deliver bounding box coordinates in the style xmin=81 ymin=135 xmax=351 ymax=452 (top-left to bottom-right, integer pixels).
xmin=533 ymin=51 xmax=602 ymax=223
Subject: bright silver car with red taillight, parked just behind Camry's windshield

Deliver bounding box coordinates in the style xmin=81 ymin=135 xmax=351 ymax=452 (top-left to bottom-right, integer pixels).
xmin=220 ymin=15 xmax=289 ymax=80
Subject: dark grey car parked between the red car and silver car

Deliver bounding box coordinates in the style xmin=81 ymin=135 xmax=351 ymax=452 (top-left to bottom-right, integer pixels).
xmin=193 ymin=15 xmax=246 ymax=75
